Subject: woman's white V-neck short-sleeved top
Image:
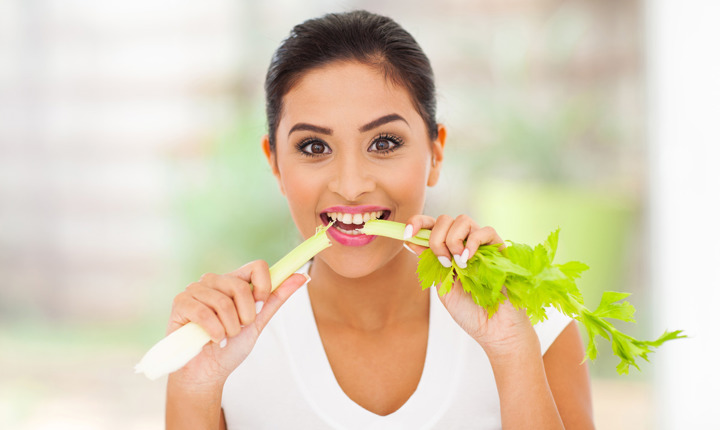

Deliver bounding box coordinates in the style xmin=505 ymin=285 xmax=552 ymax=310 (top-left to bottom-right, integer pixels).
xmin=222 ymin=265 xmax=572 ymax=430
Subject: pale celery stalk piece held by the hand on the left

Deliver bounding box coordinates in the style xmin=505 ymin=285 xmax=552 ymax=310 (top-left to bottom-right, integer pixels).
xmin=135 ymin=225 xmax=332 ymax=380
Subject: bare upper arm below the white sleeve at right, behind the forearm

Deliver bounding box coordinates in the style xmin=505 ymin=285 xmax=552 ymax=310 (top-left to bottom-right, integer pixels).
xmin=543 ymin=321 xmax=595 ymax=429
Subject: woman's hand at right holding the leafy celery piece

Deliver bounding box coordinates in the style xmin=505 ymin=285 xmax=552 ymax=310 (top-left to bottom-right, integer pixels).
xmin=407 ymin=215 xmax=539 ymax=357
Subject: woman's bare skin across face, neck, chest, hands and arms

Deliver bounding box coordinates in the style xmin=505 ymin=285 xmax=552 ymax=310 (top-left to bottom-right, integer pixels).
xmin=167 ymin=62 xmax=594 ymax=429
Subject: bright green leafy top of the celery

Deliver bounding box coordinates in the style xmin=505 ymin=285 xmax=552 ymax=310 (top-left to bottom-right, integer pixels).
xmin=408 ymin=225 xmax=686 ymax=374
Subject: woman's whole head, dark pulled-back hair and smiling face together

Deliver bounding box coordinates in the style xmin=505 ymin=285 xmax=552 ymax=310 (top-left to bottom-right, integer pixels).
xmin=263 ymin=12 xmax=445 ymax=277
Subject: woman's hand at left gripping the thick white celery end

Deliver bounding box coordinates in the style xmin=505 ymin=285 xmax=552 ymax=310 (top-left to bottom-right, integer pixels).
xmin=167 ymin=260 xmax=310 ymax=388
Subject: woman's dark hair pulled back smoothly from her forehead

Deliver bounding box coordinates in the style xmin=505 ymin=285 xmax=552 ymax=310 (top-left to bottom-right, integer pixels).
xmin=265 ymin=10 xmax=438 ymax=150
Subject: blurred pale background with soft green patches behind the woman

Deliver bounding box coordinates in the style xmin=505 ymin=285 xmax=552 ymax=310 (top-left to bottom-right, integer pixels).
xmin=0 ymin=0 xmax=720 ymax=429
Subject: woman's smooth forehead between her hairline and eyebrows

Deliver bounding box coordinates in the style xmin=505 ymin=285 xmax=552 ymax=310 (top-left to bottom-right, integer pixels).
xmin=278 ymin=62 xmax=424 ymax=136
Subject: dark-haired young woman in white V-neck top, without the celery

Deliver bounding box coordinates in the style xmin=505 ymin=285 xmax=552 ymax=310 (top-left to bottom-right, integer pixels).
xmin=166 ymin=11 xmax=593 ymax=429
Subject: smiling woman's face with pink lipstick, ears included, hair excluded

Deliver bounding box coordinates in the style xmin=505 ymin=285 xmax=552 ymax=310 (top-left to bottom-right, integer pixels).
xmin=263 ymin=58 xmax=445 ymax=277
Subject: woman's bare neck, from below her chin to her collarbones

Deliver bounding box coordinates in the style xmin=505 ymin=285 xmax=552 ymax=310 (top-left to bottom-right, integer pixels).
xmin=308 ymin=249 xmax=430 ymax=331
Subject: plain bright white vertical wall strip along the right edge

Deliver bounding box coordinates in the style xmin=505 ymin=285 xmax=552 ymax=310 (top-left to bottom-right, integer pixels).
xmin=646 ymin=0 xmax=720 ymax=429
